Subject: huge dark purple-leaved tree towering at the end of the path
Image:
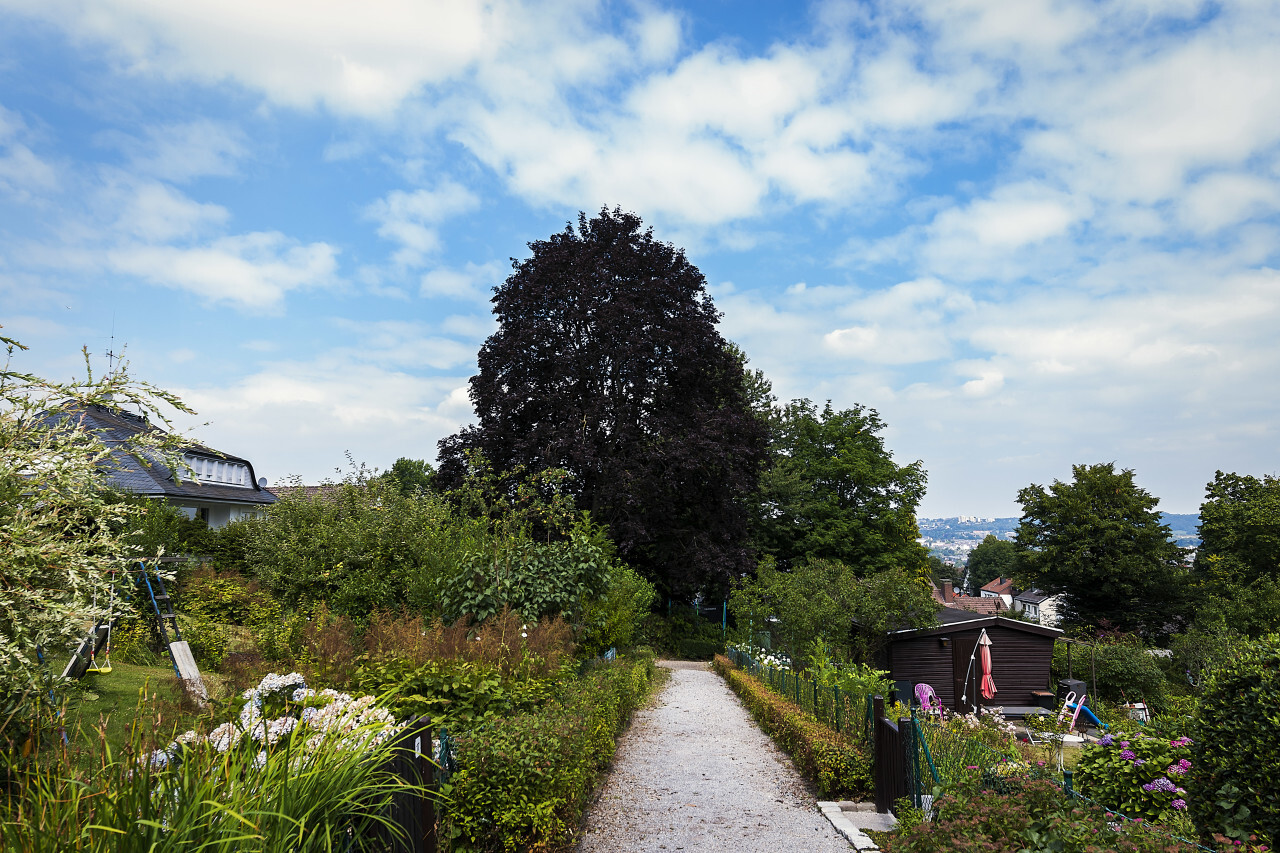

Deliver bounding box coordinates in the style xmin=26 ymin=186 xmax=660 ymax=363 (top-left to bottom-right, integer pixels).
xmin=439 ymin=209 xmax=765 ymax=596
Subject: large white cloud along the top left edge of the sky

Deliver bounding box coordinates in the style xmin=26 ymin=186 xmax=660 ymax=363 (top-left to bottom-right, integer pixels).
xmin=5 ymin=0 xmax=503 ymax=117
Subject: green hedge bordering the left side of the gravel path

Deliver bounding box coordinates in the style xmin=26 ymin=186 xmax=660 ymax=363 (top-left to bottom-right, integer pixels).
xmin=442 ymin=656 xmax=655 ymax=853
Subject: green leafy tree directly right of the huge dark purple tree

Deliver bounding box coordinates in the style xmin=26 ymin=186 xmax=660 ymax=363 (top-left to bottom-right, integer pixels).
xmin=755 ymin=400 xmax=928 ymax=575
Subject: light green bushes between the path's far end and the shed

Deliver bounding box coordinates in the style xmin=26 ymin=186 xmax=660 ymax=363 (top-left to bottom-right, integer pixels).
xmin=730 ymin=560 xmax=937 ymax=662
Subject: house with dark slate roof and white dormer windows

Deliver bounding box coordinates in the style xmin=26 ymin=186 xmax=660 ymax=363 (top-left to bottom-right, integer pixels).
xmin=50 ymin=406 xmax=275 ymax=528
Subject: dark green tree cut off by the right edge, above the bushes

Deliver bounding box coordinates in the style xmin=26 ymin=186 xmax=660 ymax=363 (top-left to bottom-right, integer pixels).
xmin=1196 ymin=471 xmax=1280 ymax=637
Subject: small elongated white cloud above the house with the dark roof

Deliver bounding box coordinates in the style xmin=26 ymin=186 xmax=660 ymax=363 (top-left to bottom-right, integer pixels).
xmin=106 ymin=232 xmax=338 ymax=310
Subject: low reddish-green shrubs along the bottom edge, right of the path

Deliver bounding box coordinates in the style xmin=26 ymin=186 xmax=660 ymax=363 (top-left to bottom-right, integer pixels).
xmin=882 ymin=781 xmax=1196 ymax=853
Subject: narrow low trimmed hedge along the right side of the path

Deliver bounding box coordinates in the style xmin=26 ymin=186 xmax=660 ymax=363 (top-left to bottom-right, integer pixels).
xmin=713 ymin=654 xmax=872 ymax=797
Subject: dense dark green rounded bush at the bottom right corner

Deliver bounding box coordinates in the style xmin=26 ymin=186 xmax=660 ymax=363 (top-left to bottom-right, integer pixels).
xmin=1189 ymin=634 xmax=1280 ymax=841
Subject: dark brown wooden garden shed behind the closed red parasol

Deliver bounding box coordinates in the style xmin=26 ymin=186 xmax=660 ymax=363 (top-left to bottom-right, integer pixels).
xmin=887 ymin=607 xmax=1062 ymax=713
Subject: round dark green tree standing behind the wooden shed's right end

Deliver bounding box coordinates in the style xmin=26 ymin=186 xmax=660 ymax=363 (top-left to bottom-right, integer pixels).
xmin=1016 ymin=462 xmax=1187 ymax=637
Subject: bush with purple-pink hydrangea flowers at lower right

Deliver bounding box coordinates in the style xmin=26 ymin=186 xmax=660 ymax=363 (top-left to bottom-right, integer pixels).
xmin=1075 ymin=733 xmax=1192 ymax=822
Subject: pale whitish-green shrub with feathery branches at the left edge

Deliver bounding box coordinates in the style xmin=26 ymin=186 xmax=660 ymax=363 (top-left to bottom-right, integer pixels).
xmin=0 ymin=337 xmax=191 ymax=697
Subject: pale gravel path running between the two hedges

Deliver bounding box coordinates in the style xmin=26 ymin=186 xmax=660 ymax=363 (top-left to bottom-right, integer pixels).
xmin=577 ymin=661 xmax=851 ymax=853
